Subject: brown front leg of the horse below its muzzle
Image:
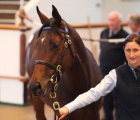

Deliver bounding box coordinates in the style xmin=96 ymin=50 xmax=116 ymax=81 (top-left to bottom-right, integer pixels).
xmin=32 ymin=97 xmax=47 ymax=120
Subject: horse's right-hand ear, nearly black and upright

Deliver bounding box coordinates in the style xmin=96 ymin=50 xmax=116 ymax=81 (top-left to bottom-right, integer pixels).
xmin=52 ymin=5 xmax=62 ymax=25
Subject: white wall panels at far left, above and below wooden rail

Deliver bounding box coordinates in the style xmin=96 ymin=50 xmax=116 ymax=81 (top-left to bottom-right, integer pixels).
xmin=0 ymin=30 xmax=24 ymax=105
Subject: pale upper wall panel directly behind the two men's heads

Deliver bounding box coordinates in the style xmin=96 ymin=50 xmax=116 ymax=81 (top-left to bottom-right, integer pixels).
xmin=101 ymin=0 xmax=140 ymax=22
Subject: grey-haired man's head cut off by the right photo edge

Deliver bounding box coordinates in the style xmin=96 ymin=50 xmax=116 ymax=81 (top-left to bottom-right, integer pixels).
xmin=128 ymin=14 xmax=140 ymax=32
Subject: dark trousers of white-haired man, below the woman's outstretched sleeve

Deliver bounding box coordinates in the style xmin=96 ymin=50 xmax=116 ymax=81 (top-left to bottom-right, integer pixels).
xmin=104 ymin=89 xmax=116 ymax=120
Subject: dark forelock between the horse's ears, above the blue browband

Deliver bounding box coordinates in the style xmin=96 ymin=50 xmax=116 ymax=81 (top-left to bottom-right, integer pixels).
xmin=38 ymin=18 xmax=61 ymax=37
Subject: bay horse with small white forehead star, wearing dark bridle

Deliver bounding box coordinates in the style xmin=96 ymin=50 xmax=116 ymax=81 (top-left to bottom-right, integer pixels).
xmin=26 ymin=6 xmax=102 ymax=120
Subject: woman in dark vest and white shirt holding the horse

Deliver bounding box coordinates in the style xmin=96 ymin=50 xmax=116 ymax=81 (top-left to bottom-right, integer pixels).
xmin=57 ymin=34 xmax=140 ymax=120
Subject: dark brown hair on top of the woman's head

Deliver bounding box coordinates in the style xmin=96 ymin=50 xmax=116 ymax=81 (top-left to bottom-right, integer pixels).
xmin=123 ymin=33 xmax=140 ymax=47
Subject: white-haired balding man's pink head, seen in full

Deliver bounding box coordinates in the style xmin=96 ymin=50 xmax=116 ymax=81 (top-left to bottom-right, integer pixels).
xmin=108 ymin=11 xmax=121 ymax=31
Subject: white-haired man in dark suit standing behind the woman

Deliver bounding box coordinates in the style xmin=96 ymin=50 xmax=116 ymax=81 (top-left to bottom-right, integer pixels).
xmin=99 ymin=11 xmax=128 ymax=120
